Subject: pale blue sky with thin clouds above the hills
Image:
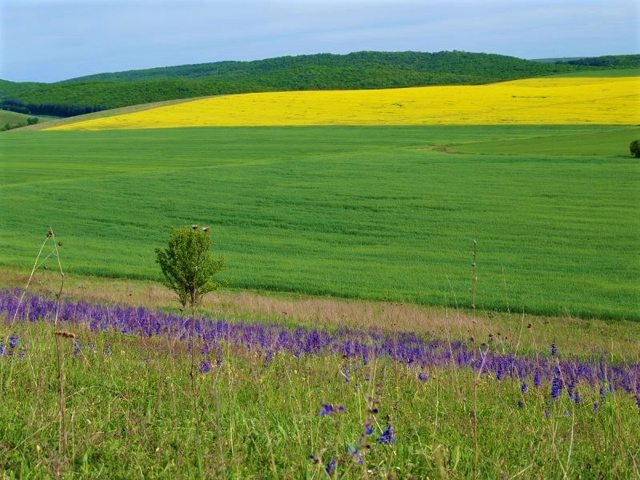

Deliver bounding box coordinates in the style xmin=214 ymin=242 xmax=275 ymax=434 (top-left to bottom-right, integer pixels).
xmin=0 ymin=0 xmax=640 ymax=82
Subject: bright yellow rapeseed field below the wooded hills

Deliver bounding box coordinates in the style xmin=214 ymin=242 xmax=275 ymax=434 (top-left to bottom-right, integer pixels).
xmin=51 ymin=77 xmax=640 ymax=130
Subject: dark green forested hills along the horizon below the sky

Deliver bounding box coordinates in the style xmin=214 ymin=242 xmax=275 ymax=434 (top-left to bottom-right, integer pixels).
xmin=0 ymin=51 xmax=640 ymax=117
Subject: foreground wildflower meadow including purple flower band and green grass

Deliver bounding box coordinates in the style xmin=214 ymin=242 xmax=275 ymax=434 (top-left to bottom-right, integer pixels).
xmin=0 ymin=286 xmax=640 ymax=478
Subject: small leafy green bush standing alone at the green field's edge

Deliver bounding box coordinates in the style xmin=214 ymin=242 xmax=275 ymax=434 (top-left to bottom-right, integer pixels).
xmin=155 ymin=225 xmax=224 ymax=307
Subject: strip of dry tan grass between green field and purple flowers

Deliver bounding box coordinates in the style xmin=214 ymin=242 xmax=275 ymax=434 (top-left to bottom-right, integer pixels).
xmin=0 ymin=267 xmax=640 ymax=358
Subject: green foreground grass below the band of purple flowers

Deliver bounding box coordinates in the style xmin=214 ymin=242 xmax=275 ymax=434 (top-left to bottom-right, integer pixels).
xmin=0 ymin=290 xmax=640 ymax=478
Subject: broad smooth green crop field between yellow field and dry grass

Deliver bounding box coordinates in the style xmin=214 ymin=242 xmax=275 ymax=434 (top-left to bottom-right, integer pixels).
xmin=0 ymin=126 xmax=640 ymax=320
